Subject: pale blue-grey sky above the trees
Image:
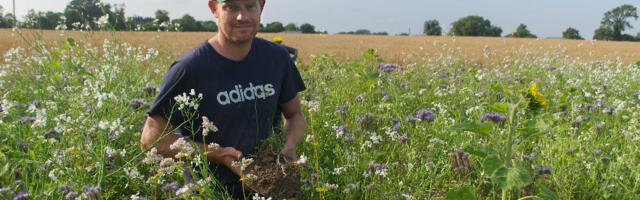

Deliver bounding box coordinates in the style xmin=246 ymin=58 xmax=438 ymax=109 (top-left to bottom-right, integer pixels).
xmin=0 ymin=0 xmax=640 ymax=39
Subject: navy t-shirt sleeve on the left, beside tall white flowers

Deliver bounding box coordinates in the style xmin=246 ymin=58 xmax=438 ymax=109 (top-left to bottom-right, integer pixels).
xmin=147 ymin=61 xmax=188 ymax=132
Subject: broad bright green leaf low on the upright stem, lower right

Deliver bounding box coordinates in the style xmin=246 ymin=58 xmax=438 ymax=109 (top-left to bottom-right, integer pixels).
xmin=491 ymin=167 xmax=531 ymax=190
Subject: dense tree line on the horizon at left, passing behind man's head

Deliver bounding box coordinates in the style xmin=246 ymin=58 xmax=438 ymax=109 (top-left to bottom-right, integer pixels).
xmin=0 ymin=0 xmax=317 ymax=33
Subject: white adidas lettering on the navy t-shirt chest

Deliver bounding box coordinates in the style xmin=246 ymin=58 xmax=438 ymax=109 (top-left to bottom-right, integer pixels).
xmin=217 ymin=83 xmax=276 ymax=106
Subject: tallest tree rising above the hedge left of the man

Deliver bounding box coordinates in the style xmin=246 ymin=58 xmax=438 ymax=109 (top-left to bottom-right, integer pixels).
xmin=64 ymin=0 xmax=111 ymax=29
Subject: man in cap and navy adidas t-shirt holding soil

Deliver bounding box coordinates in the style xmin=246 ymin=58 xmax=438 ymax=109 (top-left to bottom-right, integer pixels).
xmin=140 ymin=0 xmax=306 ymax=197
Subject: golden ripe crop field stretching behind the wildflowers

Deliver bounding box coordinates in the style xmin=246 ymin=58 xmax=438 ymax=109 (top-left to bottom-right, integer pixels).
xmin=0 ymin=29 xmax=640 ymax=64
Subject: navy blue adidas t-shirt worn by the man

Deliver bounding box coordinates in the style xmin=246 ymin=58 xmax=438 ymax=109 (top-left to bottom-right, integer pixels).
xmin=148 ymin=38 xmax=306 ymax=192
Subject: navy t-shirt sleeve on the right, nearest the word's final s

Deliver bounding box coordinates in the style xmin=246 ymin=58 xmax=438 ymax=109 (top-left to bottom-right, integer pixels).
xmin=278 ymin=55 xmax=307 ymax=104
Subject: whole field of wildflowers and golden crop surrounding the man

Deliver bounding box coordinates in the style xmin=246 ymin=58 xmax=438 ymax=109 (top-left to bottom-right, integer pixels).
xmin=0 ymin=30 xmax=640 ymax=199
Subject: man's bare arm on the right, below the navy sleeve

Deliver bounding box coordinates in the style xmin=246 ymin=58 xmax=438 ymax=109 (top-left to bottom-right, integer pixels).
xmin=280 ymin=96 xmax=307 ymax=160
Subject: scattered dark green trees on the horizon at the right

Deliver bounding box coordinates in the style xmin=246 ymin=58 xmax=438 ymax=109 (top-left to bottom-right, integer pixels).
xmin=423 ymin=5 xmax=640 ymax=41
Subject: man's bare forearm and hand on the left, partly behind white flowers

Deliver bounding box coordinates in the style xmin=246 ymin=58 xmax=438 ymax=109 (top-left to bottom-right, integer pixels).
xmin=140 ymin=115 xmax=242 ymax=175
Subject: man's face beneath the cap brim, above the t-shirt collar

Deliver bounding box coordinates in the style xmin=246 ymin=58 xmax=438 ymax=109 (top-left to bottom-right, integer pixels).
xmin=209 ymin=0 xmax=262 ymax=43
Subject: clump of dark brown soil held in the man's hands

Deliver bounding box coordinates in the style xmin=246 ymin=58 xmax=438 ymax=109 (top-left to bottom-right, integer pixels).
xmin=244 ymin=151 xmax=302 ymax=199
